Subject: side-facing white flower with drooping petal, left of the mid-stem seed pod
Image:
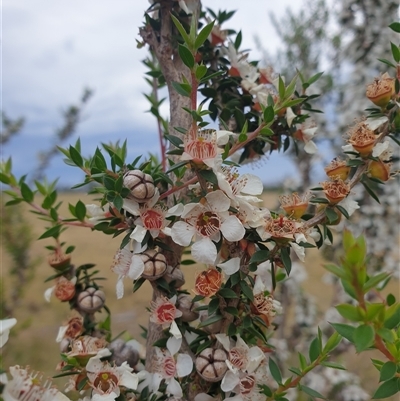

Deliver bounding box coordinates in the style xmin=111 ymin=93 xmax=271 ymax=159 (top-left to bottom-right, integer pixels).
xmin=111 ymin=245 xmax=144 ymax=299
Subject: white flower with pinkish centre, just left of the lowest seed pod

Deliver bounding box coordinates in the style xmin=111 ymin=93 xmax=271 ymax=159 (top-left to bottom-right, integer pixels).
xmin=152 ymin=337 xmax=193 ymax=397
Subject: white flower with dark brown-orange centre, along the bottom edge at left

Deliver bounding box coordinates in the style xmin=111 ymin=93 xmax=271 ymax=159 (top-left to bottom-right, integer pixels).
xmin=86 ymin=357 xmax=139 ymax=401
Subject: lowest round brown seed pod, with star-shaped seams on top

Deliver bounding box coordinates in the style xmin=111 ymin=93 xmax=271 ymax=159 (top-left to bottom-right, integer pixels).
xmin=195 ymin=348 xmax=228 ymax=382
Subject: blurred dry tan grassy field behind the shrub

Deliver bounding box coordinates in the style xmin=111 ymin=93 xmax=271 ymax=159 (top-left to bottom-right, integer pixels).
xmin=0 ymin=193 xmax=394 ymax=391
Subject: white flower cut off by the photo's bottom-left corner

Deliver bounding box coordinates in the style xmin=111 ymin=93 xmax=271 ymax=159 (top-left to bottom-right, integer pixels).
xmin=2 ymin=365 xmax=69 ymax=401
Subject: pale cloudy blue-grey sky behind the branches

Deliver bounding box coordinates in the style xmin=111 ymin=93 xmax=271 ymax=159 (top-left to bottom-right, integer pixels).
xmin=1 ymin=0 xmax=310 ymax=186
